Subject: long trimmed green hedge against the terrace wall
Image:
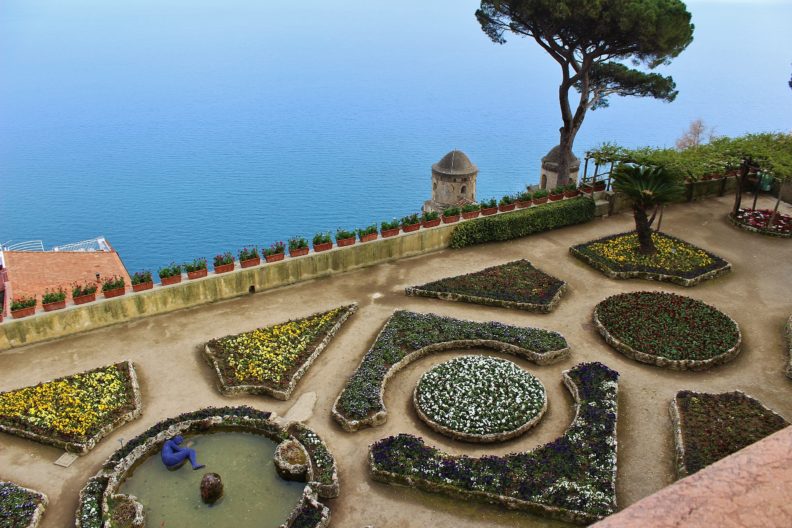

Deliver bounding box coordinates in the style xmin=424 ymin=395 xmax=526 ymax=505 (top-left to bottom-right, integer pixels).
xmin=449 ymin=196 xmax=594 ymax=248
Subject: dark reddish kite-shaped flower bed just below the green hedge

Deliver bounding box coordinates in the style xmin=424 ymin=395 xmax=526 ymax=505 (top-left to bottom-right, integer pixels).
xmin=405 ymin=260 xmax=566 ymax=313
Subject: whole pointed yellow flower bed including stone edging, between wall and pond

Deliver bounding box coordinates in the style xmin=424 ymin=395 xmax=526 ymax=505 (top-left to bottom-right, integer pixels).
xmin=204 ymin=304 xmax=357 ymax=400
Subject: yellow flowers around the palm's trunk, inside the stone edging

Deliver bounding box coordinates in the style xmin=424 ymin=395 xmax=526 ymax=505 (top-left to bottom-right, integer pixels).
xmin=586 ymin=233 xmax=715 ymax=272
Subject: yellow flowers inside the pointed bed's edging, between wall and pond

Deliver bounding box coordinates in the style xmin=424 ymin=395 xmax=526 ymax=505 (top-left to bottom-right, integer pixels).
xmin=215 ymin=307 xmax=348 ymax=385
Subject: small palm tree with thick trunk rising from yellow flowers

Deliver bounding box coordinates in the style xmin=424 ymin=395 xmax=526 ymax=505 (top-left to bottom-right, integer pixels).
xmin=613 ymin=163 xmax=683 ymax=255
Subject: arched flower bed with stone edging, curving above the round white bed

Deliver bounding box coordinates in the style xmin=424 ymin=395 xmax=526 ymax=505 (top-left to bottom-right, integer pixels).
xmin=333 ymin=310 xmax=569 ymax=431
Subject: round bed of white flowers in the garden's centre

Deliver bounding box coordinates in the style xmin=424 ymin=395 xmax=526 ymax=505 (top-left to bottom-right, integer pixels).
xmin=413 ymin=356 xmax=547 ymax=442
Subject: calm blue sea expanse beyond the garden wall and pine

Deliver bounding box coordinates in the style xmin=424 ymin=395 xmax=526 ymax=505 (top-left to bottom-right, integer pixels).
xmin=0 ymin=0 xmax=792 ymax=271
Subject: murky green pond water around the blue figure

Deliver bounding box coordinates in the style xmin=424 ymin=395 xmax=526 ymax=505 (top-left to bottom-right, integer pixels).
xmin=119 ymin=432 xmax=305 ymax=528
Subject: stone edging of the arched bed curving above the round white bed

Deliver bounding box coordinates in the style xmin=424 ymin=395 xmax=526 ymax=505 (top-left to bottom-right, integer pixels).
xmin=331 ymin=315 xmax=569 ymax=433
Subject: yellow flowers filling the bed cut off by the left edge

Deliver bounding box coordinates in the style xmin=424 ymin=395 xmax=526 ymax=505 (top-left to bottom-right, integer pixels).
xmin=0 ymin=363 xmax=131 ymax=439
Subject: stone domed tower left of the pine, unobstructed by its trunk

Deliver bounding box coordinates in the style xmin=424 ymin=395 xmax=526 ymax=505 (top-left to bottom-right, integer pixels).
xmin=424 ymin=150 xmax=478 ymax=212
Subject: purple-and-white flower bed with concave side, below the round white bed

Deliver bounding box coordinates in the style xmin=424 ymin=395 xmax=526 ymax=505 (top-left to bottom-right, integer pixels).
xmin=369 ymin=363 xmax=619 ymax=524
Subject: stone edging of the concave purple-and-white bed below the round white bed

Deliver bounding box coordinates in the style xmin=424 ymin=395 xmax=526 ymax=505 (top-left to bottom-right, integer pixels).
xmin=368 ymin=371 xmax=618 ymax=525
